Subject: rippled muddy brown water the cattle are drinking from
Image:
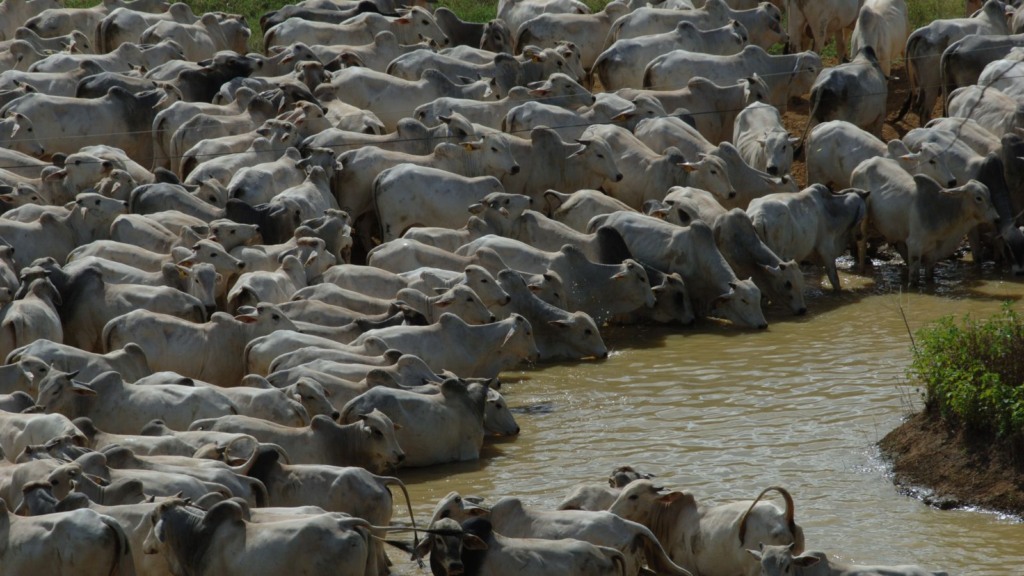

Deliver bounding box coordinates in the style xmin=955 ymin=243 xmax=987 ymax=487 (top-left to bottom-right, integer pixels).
xmin=391 ymin=263 xmax=1024 ymax=576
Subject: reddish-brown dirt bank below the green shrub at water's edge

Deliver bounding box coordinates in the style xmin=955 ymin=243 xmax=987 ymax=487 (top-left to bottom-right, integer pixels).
xmin=879 ymin=412 xmax=1024 ymax=516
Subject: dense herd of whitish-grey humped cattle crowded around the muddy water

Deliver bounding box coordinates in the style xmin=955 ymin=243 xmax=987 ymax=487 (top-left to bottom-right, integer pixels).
xmin=0 ymin=0 xmax=1024 ymax=576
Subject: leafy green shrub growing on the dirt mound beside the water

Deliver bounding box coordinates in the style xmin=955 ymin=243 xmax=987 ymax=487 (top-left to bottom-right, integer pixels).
xmin=910 ymin=304 xmax=1024 ymax=441
